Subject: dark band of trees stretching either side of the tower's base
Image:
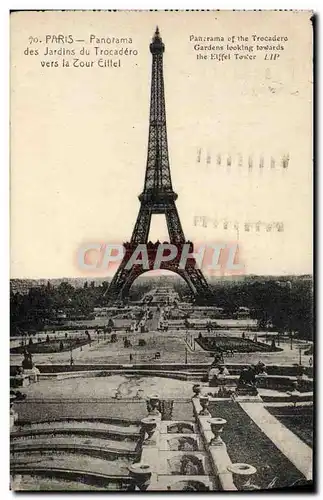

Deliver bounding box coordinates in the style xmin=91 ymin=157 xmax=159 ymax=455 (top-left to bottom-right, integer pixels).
xmin=10 ymin=277 xmax=313 ymax=339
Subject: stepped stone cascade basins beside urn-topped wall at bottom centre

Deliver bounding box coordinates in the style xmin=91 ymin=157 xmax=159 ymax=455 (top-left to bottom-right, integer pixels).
xmin=129 ymin=395 xmax=217 ymax=491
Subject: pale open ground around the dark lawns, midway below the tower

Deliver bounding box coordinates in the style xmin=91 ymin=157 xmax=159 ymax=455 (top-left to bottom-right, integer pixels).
xmin=10 ymin=330 xmax=310 ymax=366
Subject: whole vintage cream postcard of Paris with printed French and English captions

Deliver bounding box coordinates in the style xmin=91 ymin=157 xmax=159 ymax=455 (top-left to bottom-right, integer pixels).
xmin=10 ymin=10 xmax=315 ymax=492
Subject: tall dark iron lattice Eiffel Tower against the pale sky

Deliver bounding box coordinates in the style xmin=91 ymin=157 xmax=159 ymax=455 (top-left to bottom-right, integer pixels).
xmin=106 ymin=27 xmax=212 ymax=303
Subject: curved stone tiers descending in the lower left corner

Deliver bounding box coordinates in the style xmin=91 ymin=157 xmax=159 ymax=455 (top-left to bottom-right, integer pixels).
xmin=10 ymin=419 xmax=140 ymax=491
